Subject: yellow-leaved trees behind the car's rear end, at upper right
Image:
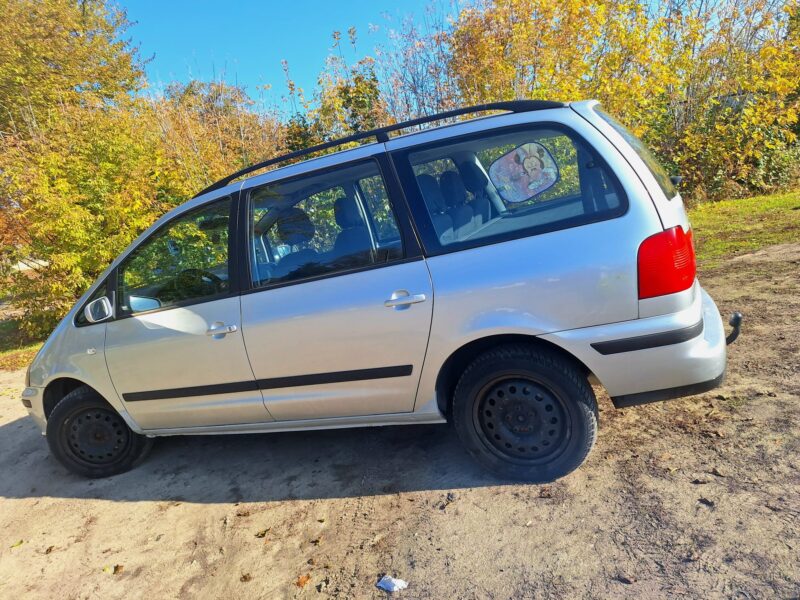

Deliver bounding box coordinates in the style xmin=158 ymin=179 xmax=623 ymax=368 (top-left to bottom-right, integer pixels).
xmin=448 ymin=0 xmax=800 ymax=199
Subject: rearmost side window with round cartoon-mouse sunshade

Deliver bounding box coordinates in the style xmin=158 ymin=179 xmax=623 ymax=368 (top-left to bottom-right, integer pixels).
xmin=394 ymin=124 xmax=627 ymax=252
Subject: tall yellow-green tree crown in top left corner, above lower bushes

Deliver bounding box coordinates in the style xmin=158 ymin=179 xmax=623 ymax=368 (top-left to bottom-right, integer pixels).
xmin=0 ymin=0 xmax=144 ymax=137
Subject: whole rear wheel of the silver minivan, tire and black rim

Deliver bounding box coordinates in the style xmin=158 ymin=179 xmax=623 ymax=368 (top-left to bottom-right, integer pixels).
xmin=452 ymin=345 xmax=597 ymax=483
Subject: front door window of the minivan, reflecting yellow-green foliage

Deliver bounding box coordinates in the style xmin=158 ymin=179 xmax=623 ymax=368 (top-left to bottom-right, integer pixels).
xmin=117 ymin=198 xmax=231 ymax=314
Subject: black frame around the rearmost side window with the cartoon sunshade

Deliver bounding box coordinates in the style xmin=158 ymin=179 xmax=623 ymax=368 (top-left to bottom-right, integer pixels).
xmin=388 ymin=121 xmax=630 ymax=258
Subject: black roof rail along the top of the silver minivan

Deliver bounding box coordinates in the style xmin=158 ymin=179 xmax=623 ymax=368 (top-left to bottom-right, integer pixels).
xmin=195 ymin=100 xmax=566 ymax=198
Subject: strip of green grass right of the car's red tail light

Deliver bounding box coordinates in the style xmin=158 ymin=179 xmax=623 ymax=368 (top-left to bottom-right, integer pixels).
xmin=689 ymin=191 xmax=800 ymax=267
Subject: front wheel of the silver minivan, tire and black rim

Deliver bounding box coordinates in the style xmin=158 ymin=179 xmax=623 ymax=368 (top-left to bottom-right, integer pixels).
xmin=47 ymin=386 xmax=153 ymax=479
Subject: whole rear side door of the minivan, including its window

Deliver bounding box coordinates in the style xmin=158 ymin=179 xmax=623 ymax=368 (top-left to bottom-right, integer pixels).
xmin=242 ymin=156 xmax=433 ymax=420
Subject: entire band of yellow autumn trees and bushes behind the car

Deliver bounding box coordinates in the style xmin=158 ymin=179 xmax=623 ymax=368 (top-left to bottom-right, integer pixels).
xmin=0 ymin=0 xmax=800 ymax=335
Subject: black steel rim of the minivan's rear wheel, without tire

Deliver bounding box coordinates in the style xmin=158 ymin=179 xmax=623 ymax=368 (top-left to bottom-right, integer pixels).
xmin=473 ymin=376 xmax=572 ymax=464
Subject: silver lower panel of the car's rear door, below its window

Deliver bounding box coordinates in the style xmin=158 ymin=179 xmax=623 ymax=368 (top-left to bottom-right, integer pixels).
xmin=242 ymin=259 xmax=434 ymax=421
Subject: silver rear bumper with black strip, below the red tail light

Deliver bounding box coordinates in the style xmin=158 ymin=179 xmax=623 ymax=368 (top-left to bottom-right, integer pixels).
xmin=542 ymin=283 xmax=727 ymax=408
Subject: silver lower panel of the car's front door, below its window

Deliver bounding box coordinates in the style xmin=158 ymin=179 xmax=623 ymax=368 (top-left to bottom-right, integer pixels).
xmin=104 ymin=296 xmax=272 ymax=429
